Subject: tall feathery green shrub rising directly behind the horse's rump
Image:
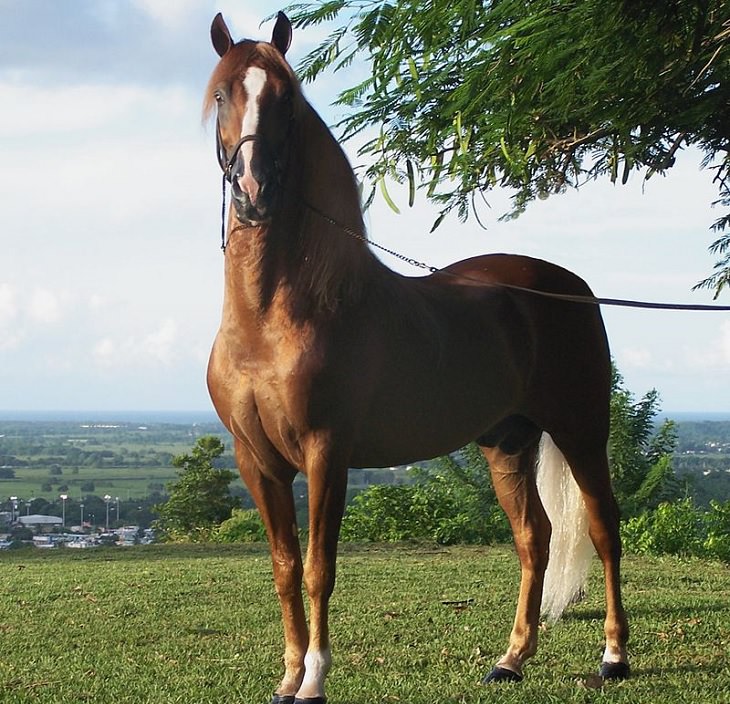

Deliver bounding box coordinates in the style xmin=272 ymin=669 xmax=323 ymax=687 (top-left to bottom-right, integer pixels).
xmin=609 ymin=367 xmax=682 ymax=516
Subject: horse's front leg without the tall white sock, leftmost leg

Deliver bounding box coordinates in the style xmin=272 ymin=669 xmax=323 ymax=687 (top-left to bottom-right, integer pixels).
xmin=236 ymin=443 xmax=309 ymax=704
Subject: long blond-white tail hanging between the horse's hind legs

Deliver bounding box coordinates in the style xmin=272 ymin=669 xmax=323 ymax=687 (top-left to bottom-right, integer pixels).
xmin=537 ymin=433 xmax=594 ymax=621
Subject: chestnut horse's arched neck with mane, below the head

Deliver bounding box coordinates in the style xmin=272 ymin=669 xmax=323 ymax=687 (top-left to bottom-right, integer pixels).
xmin=226 ymin=105 xmax=377 ymax=318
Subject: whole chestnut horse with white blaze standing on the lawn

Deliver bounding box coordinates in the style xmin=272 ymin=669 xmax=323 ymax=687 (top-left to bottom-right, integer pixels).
xmin=203 ymin=13 xmax=629 ymax=704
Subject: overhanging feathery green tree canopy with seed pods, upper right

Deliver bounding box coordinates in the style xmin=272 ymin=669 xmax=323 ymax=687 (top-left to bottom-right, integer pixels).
xmin=289 ymin=0 xmax=730 ymax=295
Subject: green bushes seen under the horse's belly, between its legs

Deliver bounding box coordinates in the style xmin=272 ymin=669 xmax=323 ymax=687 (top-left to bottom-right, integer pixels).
xmin=341 ymin=444 xmax=509 ymax=545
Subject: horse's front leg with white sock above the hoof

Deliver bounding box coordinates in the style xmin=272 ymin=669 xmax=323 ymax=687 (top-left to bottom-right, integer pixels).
xmin=296 ymin=448 xmax=347 ymax=704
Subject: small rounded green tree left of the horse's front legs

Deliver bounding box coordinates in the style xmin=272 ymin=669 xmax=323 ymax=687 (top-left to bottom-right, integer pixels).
xmin=154 ymin=435 xmax=239 ymax=542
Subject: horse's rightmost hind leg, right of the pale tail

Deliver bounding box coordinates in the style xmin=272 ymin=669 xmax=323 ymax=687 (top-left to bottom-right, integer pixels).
xmin=553 ymin=434 xmax=629 ymax=679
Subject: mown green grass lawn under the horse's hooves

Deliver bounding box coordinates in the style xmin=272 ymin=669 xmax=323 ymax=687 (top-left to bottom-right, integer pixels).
xmin=0 ymin=546 xmax=730 ymax=704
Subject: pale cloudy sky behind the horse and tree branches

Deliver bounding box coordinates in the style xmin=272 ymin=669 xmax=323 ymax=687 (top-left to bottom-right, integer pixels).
xmin=0 ymin=0 xmax=730 ymax=412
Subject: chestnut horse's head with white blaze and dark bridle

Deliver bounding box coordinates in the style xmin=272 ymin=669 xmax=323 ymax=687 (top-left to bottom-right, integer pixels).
xmin=205 ymin=12 xmax=299 ymax=225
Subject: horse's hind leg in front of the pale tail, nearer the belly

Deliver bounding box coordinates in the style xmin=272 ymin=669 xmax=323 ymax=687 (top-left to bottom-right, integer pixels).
xmin=482 ymin=420 xmax=551 ymax=683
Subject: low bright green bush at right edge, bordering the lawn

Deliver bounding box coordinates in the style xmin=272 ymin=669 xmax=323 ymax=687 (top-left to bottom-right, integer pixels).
xmin=621 ymin=499 xmax=730 ymax=562
